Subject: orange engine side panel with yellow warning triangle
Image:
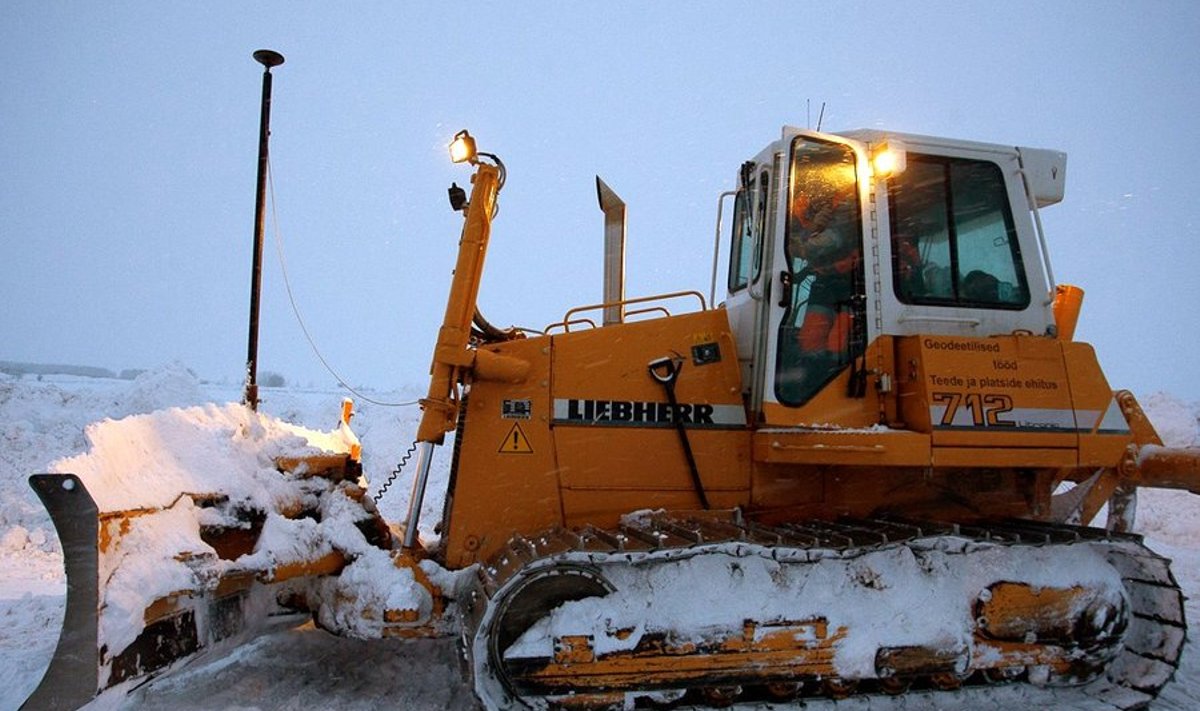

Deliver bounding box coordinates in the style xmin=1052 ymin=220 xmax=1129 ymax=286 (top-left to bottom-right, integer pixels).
xmin=443 ymin=337 xmax=563 ymax=568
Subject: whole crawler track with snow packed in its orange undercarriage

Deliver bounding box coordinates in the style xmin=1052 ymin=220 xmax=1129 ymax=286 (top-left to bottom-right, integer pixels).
xmin=463 ymin=516 xmax=1186 ymax=709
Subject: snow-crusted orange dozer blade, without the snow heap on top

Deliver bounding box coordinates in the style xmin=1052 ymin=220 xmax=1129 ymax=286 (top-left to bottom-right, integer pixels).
xmin=23 ymin=454 xmax=449 ymax=709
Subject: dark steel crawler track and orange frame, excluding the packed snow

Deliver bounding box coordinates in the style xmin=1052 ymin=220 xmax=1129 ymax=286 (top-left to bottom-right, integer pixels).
xmin=463 ymin=515 xmax=1187 ymax=710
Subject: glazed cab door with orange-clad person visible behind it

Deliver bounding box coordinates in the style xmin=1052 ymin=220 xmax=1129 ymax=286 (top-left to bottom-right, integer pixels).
xmin=760 ymin=130 xmax=877 ymax=424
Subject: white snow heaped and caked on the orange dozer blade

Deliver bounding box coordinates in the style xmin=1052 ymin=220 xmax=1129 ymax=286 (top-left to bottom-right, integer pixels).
xmin=44 ymin=404 xmax=412 ymax=651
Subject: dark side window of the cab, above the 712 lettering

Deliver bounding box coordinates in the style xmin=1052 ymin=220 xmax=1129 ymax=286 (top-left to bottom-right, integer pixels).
xmin=888 ymin=155 xmax=1030 ymax=309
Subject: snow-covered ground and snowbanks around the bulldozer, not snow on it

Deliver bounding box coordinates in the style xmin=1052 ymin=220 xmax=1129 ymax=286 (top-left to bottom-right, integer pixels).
xmin=0 ymin=365 xmax=1200 ymax=711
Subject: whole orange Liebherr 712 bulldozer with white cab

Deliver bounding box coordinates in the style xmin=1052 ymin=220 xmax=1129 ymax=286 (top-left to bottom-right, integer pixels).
xmin=26 ymin=118 xmax=1200 ymax=710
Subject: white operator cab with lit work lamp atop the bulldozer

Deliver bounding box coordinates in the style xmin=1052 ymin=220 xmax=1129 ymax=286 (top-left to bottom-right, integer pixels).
xmin=726 ymin=127 xmax=1066 ymax=424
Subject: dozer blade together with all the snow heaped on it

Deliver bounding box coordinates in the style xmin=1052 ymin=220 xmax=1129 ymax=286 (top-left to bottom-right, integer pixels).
xmin=17 ymin=396 xmax=446 ymax=709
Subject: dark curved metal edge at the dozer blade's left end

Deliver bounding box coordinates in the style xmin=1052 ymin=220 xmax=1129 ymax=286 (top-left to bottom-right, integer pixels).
xmin=22 ymin=474 xmax=100 ymax=710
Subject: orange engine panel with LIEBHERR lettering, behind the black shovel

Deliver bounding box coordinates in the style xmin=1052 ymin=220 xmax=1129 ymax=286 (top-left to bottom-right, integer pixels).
xmin=552 ymin=310 xmax=750 ymax=525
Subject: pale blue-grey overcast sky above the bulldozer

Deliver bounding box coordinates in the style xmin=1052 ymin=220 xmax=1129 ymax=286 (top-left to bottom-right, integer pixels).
xmin=0 ymin=0 xmax=1200 ymax=399
